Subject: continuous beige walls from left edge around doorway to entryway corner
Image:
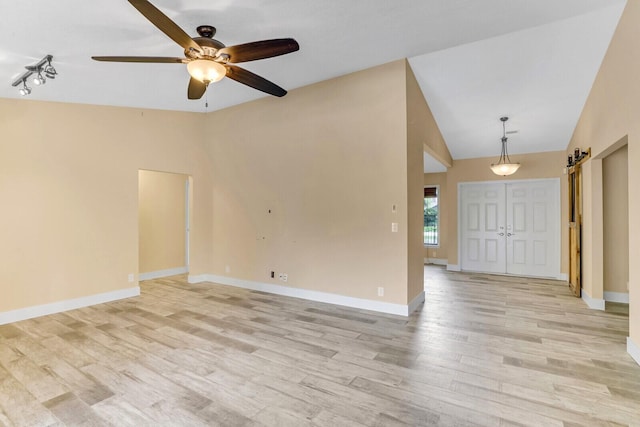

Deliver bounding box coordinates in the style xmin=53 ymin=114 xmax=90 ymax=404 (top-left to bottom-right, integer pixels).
xmin=0 ymin=60 xmax=432 ymax=311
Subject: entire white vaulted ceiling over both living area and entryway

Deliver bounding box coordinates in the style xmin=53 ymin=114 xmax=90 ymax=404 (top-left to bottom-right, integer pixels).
xmin=0 ymin=0 xmax=626 ymax=171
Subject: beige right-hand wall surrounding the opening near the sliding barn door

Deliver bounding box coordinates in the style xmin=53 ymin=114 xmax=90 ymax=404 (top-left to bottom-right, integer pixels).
xmin=568 ymin=1 xmax=640 ymax=345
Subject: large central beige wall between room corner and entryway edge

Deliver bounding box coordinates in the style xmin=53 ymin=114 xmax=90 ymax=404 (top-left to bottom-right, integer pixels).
xmin=207 ymin=61 xmax=421 ymax=304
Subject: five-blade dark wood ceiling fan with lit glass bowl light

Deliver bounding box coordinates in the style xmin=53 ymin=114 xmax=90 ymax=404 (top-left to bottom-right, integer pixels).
xmin=91 ymin=0 xmax=300 ymax=99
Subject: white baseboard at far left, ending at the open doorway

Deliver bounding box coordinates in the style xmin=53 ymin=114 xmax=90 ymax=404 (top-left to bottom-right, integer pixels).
xmin=0 ymin=286 xmax=140 ymax=325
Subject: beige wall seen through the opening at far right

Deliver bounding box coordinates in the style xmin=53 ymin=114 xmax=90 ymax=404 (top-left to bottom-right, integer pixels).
xmin=602 ymin=145 xmax=629 ymax=293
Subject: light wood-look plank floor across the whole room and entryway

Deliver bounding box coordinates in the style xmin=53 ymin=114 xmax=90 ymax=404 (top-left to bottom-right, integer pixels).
xmin=0 ymin=267 xmax=640 ymax=427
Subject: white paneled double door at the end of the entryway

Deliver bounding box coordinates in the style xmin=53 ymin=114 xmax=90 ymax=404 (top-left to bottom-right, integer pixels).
xmin=458 ymin=179 xmax=561 ymax=278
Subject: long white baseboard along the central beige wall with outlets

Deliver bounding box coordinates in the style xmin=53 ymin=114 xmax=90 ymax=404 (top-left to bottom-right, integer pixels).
xmin=189 ymin=274 xmax=416 ymax=316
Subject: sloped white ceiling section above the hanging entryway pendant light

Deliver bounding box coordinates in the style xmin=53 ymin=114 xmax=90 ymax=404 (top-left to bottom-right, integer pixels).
xmin=409 ymin=2 xmax=624 ymax=166
